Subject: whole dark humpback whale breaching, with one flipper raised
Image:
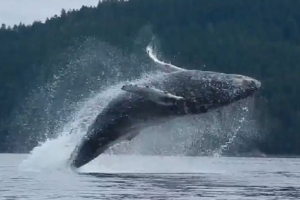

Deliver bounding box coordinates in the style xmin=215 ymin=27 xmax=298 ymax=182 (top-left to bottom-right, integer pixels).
xmin=69 ymin=46 xmax=261 ymax=169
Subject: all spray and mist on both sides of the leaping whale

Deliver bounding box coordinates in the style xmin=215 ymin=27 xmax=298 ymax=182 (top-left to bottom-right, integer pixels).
xmin=14 ymin=39 xmax=259 ymax=170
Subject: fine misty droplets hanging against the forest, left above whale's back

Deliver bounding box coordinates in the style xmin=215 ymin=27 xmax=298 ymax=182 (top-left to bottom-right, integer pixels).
xmin=9 ymin=38 xmax=154 ymax=152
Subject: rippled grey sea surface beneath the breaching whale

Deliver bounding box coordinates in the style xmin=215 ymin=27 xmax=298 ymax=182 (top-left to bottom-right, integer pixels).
xmin=0 ymin=154 xmax=300 ymax=200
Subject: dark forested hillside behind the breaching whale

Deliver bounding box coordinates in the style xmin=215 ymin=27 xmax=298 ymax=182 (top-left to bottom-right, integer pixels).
xmin=0 ymin=0 xmax=300 ymax=155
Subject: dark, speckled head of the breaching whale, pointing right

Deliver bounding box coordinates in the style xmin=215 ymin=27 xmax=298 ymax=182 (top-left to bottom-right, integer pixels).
xmin=172 ymin=70 xmax=261 ymax=108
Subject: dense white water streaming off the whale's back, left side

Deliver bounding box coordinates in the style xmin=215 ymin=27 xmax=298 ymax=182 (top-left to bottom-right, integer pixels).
xmin=21 ymin=73 xmax=164 ymax=170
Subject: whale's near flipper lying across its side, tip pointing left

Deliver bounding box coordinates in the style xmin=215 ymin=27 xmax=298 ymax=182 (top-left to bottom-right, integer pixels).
xmin=121 ymin=84 xmax=184 ymax=106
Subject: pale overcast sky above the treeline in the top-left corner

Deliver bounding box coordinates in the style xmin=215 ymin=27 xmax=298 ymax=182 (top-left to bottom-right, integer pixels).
xmin=0 ymin=0 xmax=99 ymax=26
